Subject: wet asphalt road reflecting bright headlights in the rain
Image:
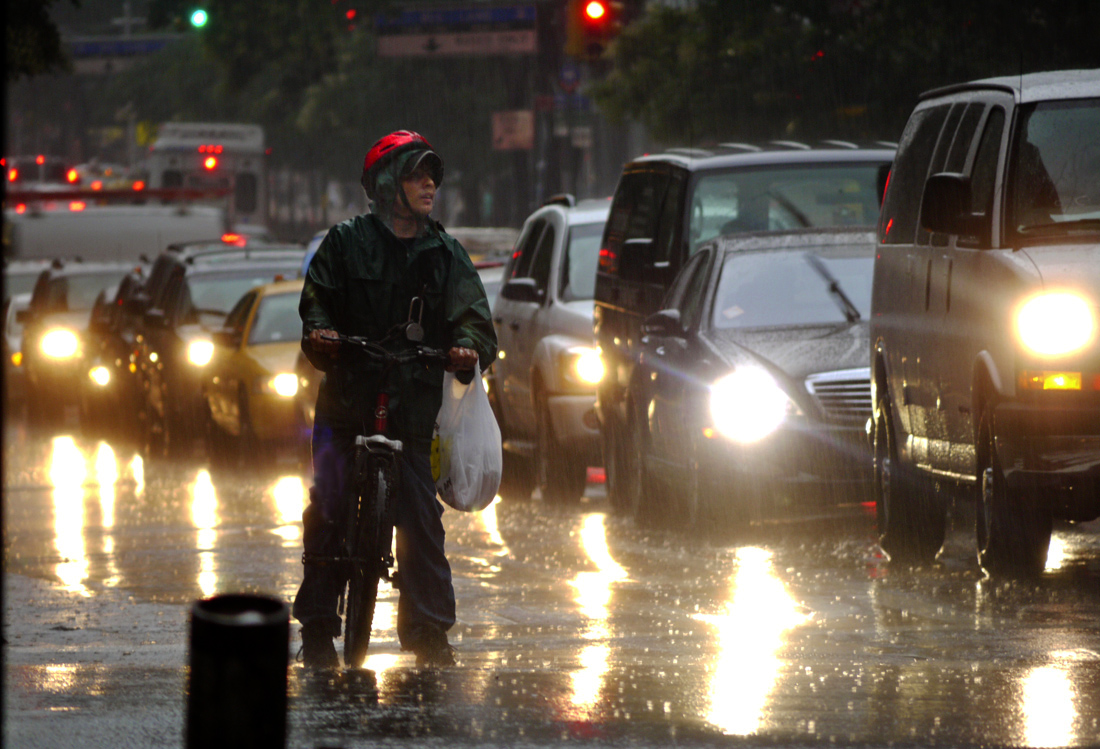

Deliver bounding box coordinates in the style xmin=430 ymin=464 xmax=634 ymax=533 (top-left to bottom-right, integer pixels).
xmin=2 ymin=426 xmax=1100 ymax=748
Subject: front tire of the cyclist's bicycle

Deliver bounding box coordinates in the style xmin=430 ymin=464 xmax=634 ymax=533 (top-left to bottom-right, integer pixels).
xmin=343 ymin=451 xmax=397 ymax=669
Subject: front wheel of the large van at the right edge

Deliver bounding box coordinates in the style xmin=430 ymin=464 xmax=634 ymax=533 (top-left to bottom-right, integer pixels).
xmin=975 ymin=406 xmax=1053 ymax=575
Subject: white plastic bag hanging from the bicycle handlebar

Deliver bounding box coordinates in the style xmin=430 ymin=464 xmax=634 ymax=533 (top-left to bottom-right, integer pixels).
xmin=431 ymin=367 xmax=504 ymax=513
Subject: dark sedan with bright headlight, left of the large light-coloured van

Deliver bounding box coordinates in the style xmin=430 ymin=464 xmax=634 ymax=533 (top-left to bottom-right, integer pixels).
xmin=627 ymin=230 xmax=875 ymax=526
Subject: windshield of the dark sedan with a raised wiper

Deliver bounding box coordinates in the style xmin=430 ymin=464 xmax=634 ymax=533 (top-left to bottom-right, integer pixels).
xmin=713 ymin=247 xmax=875 ymax=330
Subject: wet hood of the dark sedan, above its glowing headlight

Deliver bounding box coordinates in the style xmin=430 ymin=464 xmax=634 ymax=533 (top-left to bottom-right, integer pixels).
xmin=707 ymin=322 xmax=870 ymax=382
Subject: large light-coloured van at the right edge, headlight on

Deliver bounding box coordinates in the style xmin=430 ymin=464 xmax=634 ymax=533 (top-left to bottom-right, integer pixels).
xmin=871 ymin=70 xmax=1100 ymax=574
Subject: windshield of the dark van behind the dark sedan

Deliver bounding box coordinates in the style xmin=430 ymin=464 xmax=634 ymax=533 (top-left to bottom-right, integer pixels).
xmin=690 ymin=164 xmax=880 ymax=249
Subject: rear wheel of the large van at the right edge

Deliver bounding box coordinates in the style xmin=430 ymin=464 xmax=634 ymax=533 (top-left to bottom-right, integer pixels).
xmin=875 ymin=398 xmax=947 ymax=564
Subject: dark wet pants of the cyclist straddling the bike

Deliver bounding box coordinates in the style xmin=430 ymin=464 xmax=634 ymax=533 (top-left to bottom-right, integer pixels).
xmin=293 ymin=423 xmax=454 ymax=650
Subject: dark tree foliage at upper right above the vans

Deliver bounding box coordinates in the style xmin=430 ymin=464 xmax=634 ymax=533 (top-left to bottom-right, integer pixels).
xmin=590 ymin=0 xmax=1100 ymax=143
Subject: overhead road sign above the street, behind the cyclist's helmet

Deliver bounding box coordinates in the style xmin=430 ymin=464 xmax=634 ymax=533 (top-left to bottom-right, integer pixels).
xmin=375 ymin=5 xmax=538 ymax=57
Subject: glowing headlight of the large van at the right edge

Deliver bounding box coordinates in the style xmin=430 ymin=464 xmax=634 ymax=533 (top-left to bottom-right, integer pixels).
xmin=1016 ymin=291 xmax=1097 ymax=356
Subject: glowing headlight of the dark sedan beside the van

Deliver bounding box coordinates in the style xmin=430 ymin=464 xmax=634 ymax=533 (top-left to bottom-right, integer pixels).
xmin=711 ymin=367 xmax=798 ymax=442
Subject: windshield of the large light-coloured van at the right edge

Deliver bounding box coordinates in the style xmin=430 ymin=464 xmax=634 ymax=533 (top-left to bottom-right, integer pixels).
xmin=1010 ymin=99 xmax=1100 ymax=233
